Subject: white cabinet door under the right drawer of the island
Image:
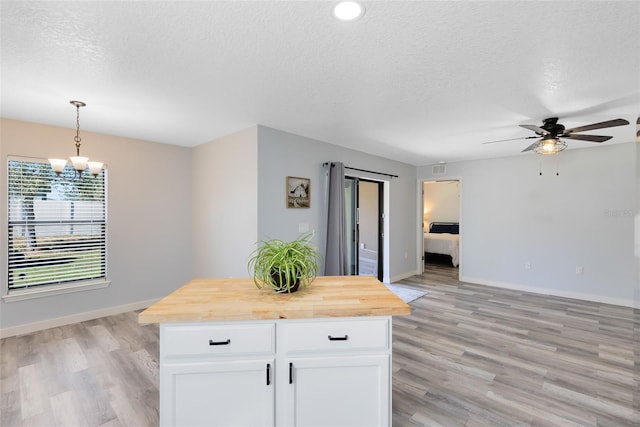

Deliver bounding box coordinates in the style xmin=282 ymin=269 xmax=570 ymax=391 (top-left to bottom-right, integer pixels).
xmin=278 ymin=355 xmax=391 ymax=427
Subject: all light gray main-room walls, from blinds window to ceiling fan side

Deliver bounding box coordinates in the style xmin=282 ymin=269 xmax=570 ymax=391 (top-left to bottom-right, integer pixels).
xmin=5 ymin=119 xmax=640 ymax=329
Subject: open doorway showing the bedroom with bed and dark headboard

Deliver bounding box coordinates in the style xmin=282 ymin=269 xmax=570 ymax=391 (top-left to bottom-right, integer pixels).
xmin=420 ymin=179 xmax=461 ymax=272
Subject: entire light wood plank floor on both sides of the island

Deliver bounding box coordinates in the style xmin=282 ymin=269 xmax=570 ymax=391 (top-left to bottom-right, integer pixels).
xmin=0 ymin=265 xmax=640 ymax=427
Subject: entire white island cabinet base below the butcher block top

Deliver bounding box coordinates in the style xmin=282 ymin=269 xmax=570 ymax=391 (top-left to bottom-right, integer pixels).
xmin=160 ymin=316 xmax=391 ymax=427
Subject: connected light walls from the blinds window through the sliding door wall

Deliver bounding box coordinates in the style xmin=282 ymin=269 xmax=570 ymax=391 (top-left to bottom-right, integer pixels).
xmin=0 ymin=119 xmax=417 ymax=331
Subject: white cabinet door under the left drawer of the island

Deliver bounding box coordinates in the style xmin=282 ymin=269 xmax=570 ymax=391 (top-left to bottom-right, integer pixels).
xmin=160 ymin=359 xmax=275 ymax=427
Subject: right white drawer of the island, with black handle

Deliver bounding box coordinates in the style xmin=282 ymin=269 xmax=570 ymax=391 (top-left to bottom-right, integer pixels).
xmin=282 ymin=319 xmax=390 ymax=354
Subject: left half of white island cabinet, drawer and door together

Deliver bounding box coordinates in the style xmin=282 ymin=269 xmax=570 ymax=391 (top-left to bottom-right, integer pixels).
xmin=160 ymin=322 xmax=275 ymax=427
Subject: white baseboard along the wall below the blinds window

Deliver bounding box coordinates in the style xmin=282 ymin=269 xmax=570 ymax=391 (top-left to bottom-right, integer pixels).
xmin=0 ymin=298 xmax=160 ymax=338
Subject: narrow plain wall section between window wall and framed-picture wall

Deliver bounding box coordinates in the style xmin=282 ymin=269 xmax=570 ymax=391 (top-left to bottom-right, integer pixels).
xmin=191 ymin=126 xmax=258 ymax=277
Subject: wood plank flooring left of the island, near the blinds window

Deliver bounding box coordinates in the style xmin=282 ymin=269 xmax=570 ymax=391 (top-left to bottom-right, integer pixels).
xmin=0 ymin=312 xmax=159 ymax=427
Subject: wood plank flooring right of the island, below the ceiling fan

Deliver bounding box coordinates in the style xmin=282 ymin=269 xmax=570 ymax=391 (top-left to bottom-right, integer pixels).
xmin=393 ymin=265 xmax=640 ymax=427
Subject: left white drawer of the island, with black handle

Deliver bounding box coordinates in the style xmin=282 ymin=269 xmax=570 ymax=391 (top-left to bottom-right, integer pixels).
xmin=160 ymin=323 xmax=275 ymax=358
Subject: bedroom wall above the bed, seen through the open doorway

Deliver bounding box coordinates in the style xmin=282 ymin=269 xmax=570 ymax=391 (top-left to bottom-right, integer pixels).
xmin=423 ymin=181 xmax=460 ymax=226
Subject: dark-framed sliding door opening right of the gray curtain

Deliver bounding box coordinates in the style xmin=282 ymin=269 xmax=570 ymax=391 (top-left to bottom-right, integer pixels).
xmin=345 ymin=176 xmax=384 ymax=281
